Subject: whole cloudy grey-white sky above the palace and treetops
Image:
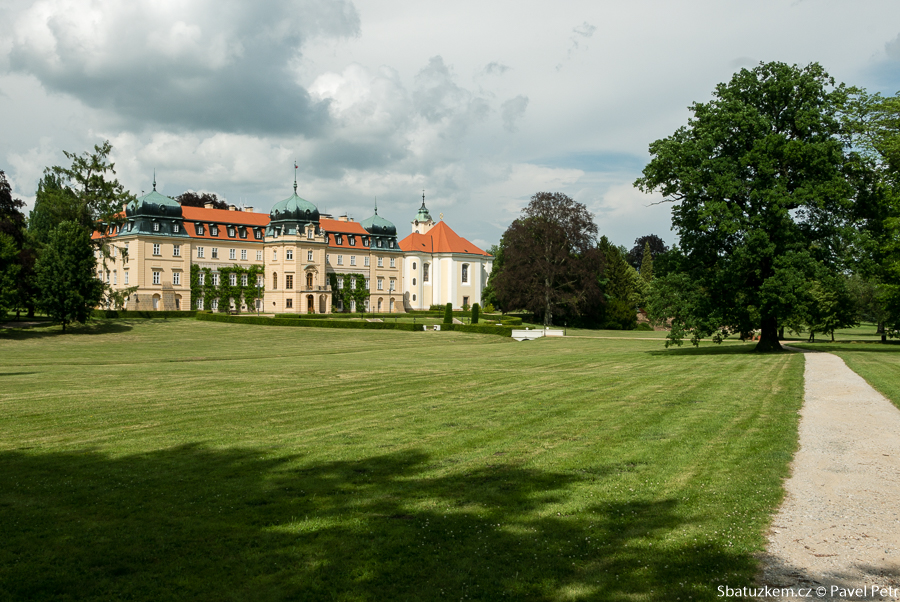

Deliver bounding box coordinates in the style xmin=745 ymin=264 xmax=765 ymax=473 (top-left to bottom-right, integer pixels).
xmin=0 ymin=0 xmax=900 ymax=247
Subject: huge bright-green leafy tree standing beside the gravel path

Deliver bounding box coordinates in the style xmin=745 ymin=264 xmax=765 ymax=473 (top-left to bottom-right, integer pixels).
xmin=635 ymin=63 xmax=855 ymax=351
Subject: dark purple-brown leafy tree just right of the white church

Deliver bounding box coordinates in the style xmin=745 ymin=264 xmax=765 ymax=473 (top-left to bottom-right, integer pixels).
xmin=491 ymin=192 xmax=602 ymax=326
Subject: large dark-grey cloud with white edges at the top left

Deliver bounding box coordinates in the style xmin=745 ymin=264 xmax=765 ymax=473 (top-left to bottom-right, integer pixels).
xmin=8 ymin=0 xmax=359 ymax=134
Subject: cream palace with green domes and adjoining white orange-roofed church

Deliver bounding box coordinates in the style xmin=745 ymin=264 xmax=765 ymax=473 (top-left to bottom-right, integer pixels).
xmin=94 ymin=179 xmax=493 ymax=314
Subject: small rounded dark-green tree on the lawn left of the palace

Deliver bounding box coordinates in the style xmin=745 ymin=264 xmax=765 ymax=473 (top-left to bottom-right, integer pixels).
xmin=36 ymin=222 xmax=103 ymax=332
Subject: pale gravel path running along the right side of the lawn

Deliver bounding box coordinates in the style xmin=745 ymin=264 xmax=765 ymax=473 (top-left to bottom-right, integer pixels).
xmin=760 ymin=352 xmax=900 ymax=600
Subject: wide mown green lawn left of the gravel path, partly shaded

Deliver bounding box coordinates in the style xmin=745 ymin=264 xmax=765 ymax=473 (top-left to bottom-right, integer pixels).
xmin=0 ymin=320 xmax=803 ymax=600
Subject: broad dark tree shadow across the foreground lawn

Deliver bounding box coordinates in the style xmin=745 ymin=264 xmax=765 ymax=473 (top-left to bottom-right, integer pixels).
xmin=0 ymin=446 xmax=756 ymax=600
